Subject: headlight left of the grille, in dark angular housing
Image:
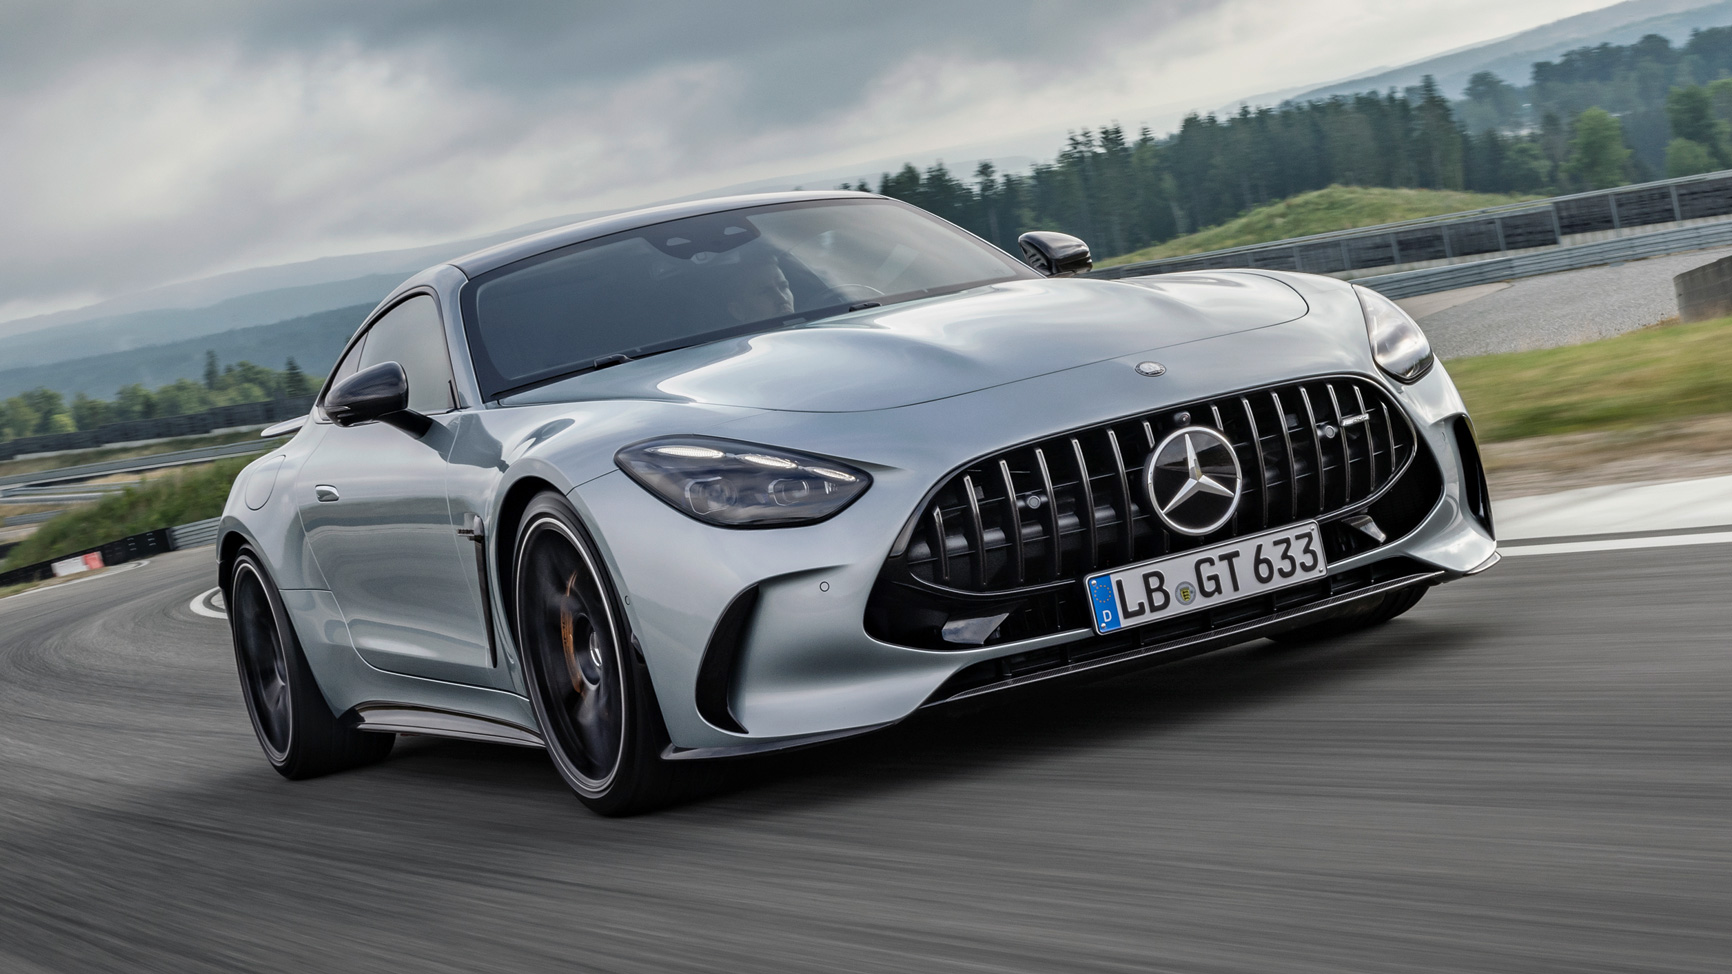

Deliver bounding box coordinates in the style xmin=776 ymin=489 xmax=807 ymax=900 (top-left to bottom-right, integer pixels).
xmin=613 ymin=437 xmax=871 ymax=527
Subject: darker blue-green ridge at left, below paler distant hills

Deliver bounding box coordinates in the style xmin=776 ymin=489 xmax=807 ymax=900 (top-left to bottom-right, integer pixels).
xmin=0 ymin=302 xmax=372 ymax=399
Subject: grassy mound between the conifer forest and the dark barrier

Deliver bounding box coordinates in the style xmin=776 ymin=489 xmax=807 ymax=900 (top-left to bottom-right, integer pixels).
xmin=1100 ymin=185 xmax=1538 ymax=267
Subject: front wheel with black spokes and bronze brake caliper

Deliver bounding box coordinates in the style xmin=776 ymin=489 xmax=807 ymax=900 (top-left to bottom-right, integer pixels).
xmin=511 ymin=492 xmax=675 ymax=816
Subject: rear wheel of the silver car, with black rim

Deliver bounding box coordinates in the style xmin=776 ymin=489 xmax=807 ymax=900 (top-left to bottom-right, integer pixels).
xmin=227 ymin=548 xmax=397 ymax=780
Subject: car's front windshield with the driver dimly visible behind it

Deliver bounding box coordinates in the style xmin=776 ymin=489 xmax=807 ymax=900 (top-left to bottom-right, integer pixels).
xmin=462 ymin=199 xmax=1036 ymax=399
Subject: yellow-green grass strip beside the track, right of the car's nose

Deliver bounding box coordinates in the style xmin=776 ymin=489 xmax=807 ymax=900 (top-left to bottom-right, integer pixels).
xmin=1450 ymin=317 xmax=1732 ymax=442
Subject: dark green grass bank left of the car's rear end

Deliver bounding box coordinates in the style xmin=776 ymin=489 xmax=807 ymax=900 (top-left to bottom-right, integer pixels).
xmin=0 ymin=458 xmax=251 ymax=572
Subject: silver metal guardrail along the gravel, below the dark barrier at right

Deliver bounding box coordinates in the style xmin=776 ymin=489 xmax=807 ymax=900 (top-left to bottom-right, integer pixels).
xmin=1356 ymin=220 xmax=1732 ymax=298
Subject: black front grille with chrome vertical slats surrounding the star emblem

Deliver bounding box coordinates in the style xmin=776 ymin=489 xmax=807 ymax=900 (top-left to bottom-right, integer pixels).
xmin=866 ymin=376 xmax=1443 ymax=648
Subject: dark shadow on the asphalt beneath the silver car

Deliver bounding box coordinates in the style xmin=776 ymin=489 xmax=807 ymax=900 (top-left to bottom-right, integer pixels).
xmin=379 ymin=617 xmax=1483 ymax=815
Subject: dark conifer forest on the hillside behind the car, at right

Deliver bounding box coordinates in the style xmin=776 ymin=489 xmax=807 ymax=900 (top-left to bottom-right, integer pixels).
xmin=862 ymin=26 xmax=1732 ymax=256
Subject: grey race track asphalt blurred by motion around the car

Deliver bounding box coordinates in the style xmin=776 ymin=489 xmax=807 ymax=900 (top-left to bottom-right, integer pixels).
xmin=0 ymin=544 xmax=1732 ymax=974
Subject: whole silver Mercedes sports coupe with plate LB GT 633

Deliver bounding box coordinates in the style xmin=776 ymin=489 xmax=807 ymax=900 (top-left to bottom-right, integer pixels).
xmin=218 ymin=192 xmax=1498 ymax=815
